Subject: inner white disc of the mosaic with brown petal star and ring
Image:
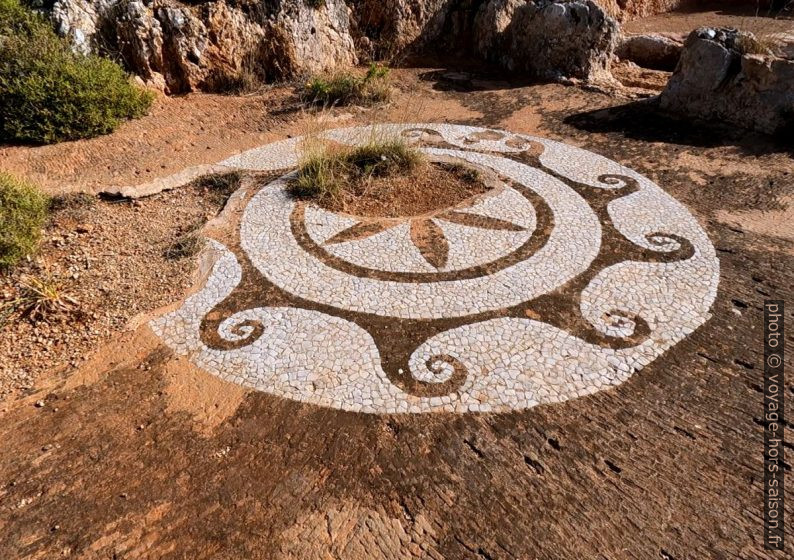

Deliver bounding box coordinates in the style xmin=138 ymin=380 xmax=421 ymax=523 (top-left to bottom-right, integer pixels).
xmin=241 ymin=144 xmax=601 ymax=319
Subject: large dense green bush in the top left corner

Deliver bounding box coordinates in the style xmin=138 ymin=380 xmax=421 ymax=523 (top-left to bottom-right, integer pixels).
xmin=0 ymin=0 xmax=153 ymax=143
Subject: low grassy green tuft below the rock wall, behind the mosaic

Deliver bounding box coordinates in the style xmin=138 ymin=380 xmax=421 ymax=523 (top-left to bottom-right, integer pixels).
xmin=303 ymin=63 xmax=391 ymax=105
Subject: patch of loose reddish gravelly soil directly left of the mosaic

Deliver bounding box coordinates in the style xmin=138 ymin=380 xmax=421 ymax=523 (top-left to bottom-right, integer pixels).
xmin=0 ymin=182 xmax=235 ymax=401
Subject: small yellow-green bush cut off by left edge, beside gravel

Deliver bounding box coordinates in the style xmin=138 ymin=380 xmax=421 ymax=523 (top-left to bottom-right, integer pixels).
xmin=0 ymin=171 xmax=49 ymax=268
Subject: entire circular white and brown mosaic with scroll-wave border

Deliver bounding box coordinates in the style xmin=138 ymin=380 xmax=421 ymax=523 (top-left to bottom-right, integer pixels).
xmin=151 ymin=124 xmax=719 ymax=413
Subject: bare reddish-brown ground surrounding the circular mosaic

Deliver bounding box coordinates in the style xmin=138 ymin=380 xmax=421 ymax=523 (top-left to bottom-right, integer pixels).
xmin=0 ymin=38 xmax=794 ymax=560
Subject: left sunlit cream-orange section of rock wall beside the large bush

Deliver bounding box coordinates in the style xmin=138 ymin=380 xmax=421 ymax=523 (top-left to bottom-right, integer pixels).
xmin=52 ymin=0 xmax=357 ymax=93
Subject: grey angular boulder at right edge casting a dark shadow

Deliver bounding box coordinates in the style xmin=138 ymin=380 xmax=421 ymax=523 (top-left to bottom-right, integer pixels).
xmin=661 ymin=28 xmax=794 ymax=134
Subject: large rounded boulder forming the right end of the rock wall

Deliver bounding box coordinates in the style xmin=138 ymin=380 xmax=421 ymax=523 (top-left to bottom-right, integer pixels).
xmin=475 ymin=0 xmax=619 ymax=81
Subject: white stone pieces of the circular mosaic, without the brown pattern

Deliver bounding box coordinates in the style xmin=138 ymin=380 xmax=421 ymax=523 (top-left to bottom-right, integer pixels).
xmin=151 ymin=124 xmax=719 ymax=413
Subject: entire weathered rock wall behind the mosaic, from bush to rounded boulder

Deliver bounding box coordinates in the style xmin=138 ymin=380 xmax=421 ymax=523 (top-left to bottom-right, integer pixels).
xmin=52 ymin=0 xmax=617 ymax=89
